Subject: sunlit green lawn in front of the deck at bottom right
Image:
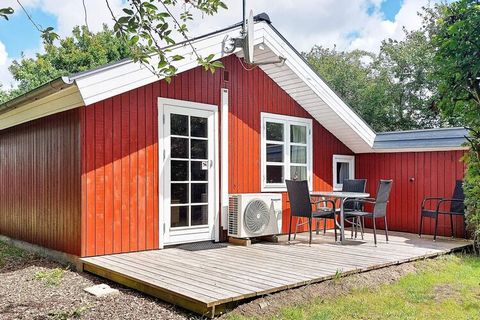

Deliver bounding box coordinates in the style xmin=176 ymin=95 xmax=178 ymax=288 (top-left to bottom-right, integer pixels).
xmin=230 ymin=255 xmax=480 ymax=320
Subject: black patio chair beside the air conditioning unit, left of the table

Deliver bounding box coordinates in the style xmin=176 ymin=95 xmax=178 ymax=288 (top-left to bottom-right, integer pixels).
xmin=285 ymin=180 xmax=337 ymax=244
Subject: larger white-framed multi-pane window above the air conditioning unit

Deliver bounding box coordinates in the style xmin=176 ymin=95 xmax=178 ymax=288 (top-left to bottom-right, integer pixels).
xmin=260 ymin=112 xmax=313 ymax=191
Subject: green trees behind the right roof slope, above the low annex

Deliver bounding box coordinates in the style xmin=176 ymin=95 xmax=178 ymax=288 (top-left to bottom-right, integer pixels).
xmin=306 ymin=31 xmax=440 ymax=132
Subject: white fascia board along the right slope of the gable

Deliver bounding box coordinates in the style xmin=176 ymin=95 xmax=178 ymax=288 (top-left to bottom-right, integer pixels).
xmin=259 ymin=23 xmax=376 ymax=152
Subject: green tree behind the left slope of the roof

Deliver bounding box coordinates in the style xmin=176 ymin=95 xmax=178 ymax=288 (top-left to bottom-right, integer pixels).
xmin=0 ymin=26 xmax=130 ymax=102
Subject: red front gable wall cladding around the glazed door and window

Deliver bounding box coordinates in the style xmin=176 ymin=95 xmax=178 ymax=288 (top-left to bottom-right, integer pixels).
xmin=81 ymin=56 xmax=352 ymax=256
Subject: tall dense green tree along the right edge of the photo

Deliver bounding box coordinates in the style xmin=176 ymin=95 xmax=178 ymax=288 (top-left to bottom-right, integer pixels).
xmin=425 ymin=0 xmax=480 ymax=248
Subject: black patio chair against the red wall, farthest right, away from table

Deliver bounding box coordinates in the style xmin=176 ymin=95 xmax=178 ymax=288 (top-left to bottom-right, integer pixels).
xmin=418 ymin=180 xmax=467 ymax=241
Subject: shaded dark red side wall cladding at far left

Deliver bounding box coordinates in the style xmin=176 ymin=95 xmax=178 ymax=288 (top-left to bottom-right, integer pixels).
xmin=0 ymin=109 xmax=81 ymax=255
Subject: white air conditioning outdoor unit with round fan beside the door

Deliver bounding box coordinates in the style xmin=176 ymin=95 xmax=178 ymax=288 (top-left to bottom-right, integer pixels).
xmin=228 ymin=193 xmax=282 ymax=238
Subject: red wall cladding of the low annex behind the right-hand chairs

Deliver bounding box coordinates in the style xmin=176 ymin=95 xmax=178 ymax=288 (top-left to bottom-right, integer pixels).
xmin=355 ymin=151 xmax=464 ymax=237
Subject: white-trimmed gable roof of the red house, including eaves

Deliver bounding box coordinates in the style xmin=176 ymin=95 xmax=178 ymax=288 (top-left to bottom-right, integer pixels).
xmin=0 ymin=14 xmax=466 ymax=153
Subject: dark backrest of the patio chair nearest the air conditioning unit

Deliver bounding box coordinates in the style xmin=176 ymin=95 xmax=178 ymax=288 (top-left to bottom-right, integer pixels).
xmin=285 ymin=180 xmax=312 ymax=217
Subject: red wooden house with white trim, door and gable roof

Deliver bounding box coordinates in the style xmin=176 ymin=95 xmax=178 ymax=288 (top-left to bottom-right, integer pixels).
xmin=0 ymin=15 xmax=465 ymax=257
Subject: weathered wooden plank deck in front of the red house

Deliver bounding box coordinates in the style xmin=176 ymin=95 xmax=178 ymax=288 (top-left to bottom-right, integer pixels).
xmin=82 ymin=232 xmax=471 ymax=315
